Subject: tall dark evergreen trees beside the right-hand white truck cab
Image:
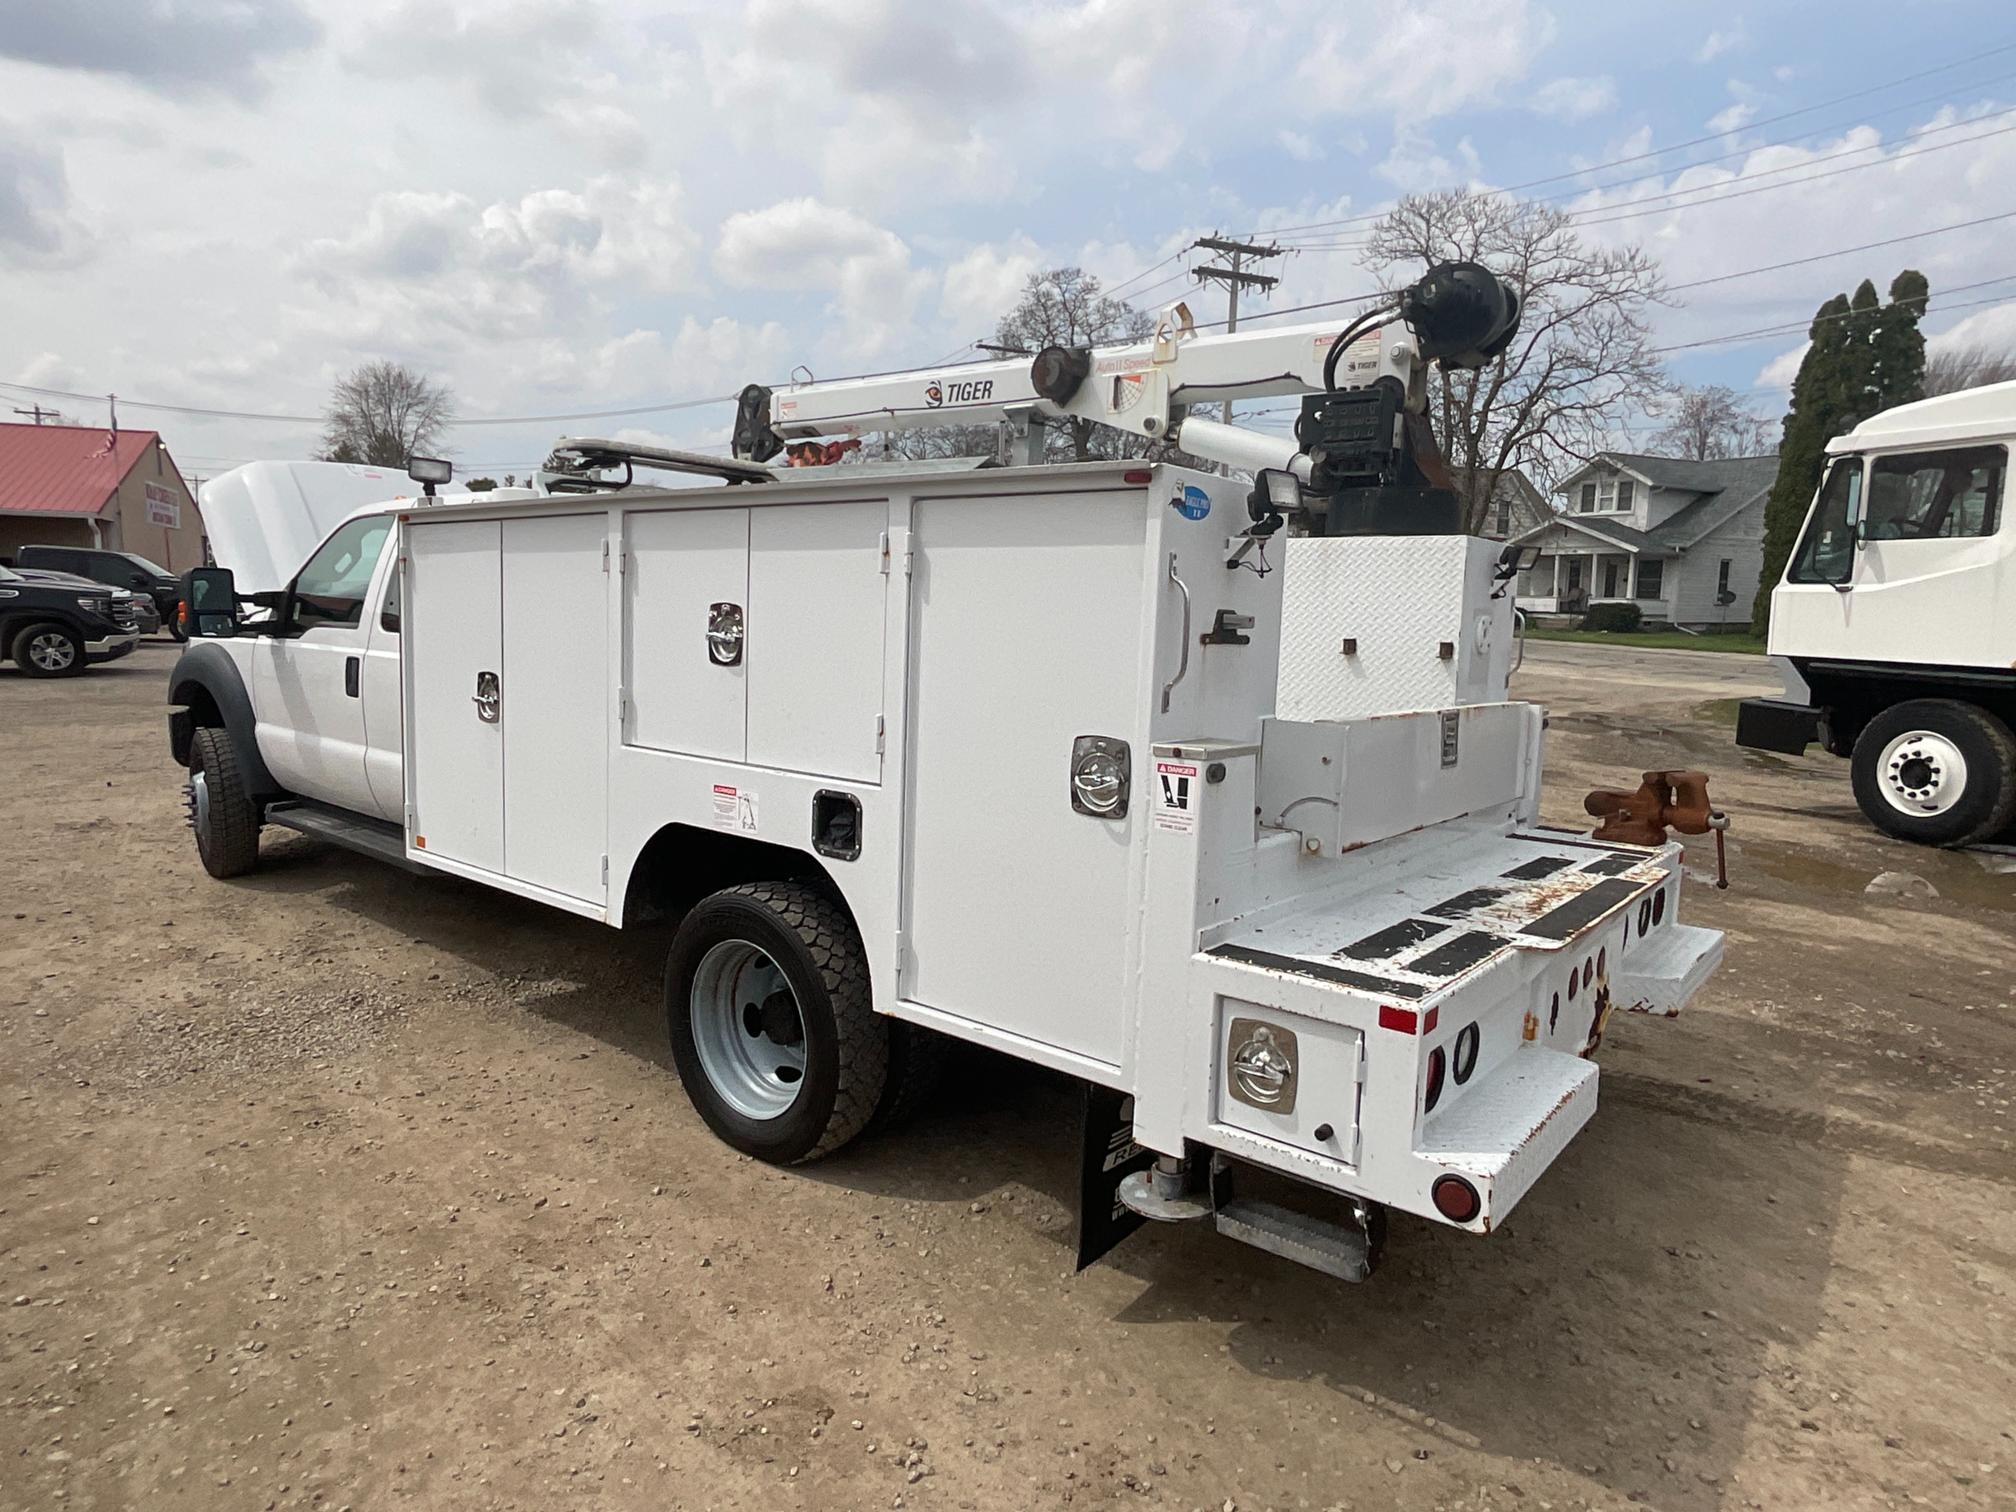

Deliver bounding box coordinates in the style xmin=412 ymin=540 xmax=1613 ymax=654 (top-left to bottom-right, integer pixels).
xmin=1750 ymin=268 xmax=1931 ymax=635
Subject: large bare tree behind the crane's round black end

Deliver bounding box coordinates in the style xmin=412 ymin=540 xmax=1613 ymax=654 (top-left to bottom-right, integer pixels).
xmin=1365 ymin=190 xmax=1667 ymax=532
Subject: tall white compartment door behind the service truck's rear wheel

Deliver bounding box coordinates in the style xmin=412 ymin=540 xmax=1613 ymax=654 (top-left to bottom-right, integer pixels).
xmin=901 ymin=490 xmax=1145 ymax=1066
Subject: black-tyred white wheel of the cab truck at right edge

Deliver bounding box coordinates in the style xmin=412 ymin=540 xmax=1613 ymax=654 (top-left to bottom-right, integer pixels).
xmin=1853 ymin=698 xmax=2016 ymax=845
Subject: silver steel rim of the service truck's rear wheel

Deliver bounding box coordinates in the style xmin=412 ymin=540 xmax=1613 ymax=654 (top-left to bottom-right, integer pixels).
xmin=687 ymin=939 xmax=804 ymax=1123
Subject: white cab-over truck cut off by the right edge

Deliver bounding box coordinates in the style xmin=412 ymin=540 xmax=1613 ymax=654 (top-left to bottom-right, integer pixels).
xmin=1736 ymin=383 xmax=2016 ymax=845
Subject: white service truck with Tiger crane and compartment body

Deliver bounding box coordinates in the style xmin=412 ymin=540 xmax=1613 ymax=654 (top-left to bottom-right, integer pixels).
xmin=169 ymin=270 xmax=1722 ymax=1280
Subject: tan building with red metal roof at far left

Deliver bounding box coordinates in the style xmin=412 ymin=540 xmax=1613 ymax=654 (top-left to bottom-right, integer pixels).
xmin=0 ymin=425 xmax=204 ymax=573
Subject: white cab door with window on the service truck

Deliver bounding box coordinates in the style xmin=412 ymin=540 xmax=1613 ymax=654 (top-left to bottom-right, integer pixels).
xmin=252 ymin=514 xmax=393 ymax=814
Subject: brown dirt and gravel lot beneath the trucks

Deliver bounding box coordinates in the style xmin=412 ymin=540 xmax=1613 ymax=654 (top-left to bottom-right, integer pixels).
xmin=0 ymin=645 xmax=2016 ymax=1512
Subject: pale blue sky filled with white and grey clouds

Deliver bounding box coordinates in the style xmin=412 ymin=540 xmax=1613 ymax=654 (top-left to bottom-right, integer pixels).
xmin=0 ymin=0 xmax=2016 ymax=474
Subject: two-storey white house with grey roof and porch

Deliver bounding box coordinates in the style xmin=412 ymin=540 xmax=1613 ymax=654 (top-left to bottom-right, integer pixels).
xmin=1514 ymin=452 xmax=1778 ymax=629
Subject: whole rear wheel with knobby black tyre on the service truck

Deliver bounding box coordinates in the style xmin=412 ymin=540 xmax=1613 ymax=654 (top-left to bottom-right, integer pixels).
xmin=665 ymin=883 xmax=889 ymax=1165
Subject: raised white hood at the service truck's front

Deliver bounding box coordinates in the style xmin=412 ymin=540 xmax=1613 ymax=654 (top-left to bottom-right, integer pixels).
xmin=198 ymin=462 xmax=419 ymax=593
